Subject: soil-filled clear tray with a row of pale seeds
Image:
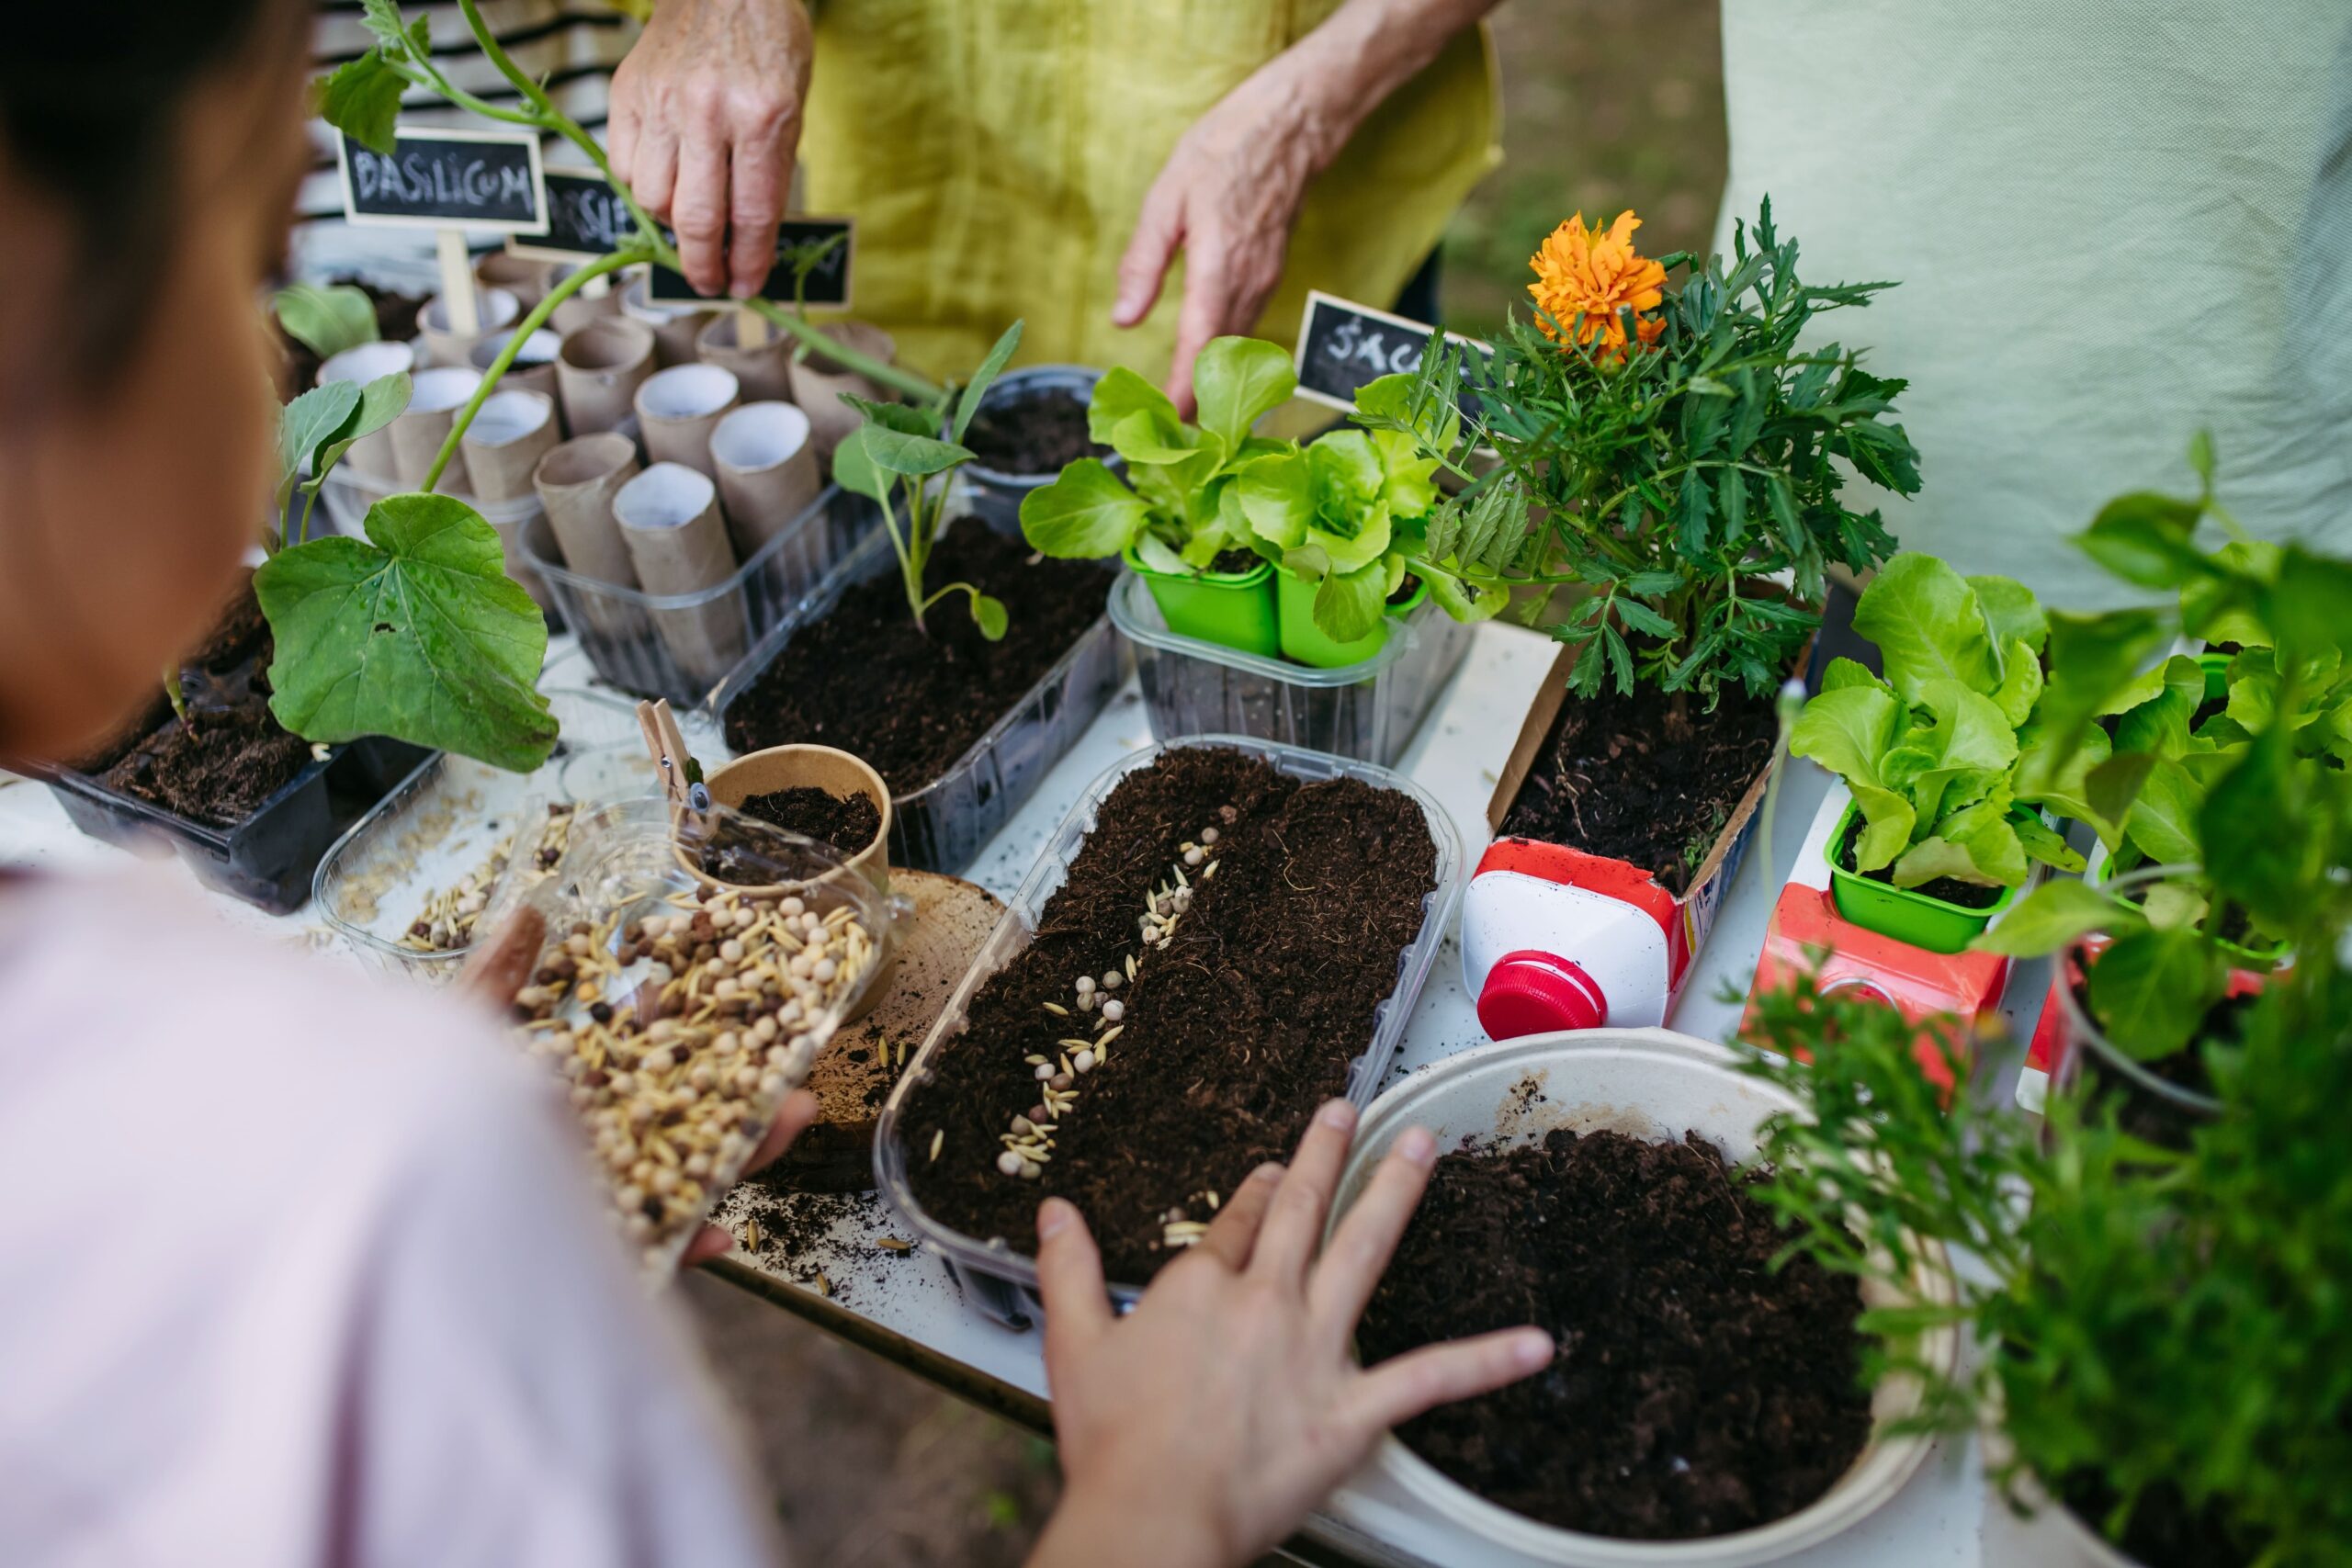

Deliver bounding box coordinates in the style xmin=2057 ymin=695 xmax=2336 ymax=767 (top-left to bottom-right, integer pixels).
xmin=875 ymin=736 xmax=1461 ymax=1324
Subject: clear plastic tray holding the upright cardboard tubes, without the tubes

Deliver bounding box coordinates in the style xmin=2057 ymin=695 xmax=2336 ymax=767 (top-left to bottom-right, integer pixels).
xmin=522 ymin=484 xmax=889 ymax=703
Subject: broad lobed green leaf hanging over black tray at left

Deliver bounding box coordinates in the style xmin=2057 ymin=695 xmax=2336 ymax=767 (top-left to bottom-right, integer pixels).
xmin=254 ymin=496 xmax=555 ymax=773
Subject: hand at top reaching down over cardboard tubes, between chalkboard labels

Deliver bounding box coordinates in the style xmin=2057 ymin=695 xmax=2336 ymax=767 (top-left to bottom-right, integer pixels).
xmin=606 ymin=0 xmax=811 ymax=299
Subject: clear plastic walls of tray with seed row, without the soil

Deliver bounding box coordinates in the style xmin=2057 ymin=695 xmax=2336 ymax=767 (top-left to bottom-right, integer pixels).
xmin=875 ymin=736 xmax=1463 ymax=1328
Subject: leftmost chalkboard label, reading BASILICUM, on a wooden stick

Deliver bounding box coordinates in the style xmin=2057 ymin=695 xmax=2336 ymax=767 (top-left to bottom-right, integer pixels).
xmin=336 ymin=130 xmax=548 ymax=235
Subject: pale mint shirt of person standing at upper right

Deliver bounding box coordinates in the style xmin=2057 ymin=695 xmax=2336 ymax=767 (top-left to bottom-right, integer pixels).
xmin=1719 ymin=0 xmax=2352 ymax=606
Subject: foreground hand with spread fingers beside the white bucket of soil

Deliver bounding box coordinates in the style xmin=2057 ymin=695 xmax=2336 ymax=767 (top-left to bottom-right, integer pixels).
xmin=1030 ymin=1100 xmax=1553 ymax=1568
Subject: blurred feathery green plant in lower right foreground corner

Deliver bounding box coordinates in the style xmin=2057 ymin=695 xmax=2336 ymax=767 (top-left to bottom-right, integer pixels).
xmin=1747 ymin=968 xmax=2352 ymax=1568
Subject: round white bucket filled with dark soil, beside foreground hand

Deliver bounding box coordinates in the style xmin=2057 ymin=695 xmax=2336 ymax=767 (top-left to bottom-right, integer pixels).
xmin=1329 ymin=1027 xmax=1959 ymax=1568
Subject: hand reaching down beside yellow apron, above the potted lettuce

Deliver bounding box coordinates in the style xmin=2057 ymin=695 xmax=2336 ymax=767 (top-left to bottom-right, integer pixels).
xmin=1110 ymin=56 xmax=1334 ymax=416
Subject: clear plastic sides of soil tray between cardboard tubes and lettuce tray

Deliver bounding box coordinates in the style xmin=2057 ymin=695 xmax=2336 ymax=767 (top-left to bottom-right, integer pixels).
xmin=710 ymin=529 xmax=1126 ymax=874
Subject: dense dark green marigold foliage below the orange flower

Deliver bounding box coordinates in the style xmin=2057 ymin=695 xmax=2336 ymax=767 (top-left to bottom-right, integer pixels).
xmin=1355 ymin=202 xmax=1919 ymax=705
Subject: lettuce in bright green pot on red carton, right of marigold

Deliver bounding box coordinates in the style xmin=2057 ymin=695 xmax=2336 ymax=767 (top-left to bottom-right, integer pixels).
xmin=1790 ymin=552 xmax=2105 ymax=952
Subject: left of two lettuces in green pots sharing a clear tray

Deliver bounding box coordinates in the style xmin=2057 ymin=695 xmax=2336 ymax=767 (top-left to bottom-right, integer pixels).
xmin=1021 ymin=339 xmax=1298 ymax=659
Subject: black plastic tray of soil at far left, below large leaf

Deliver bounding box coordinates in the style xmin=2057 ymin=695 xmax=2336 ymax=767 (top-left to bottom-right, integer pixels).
xmin=28 ymin=583 xmax=428 ymax=915
